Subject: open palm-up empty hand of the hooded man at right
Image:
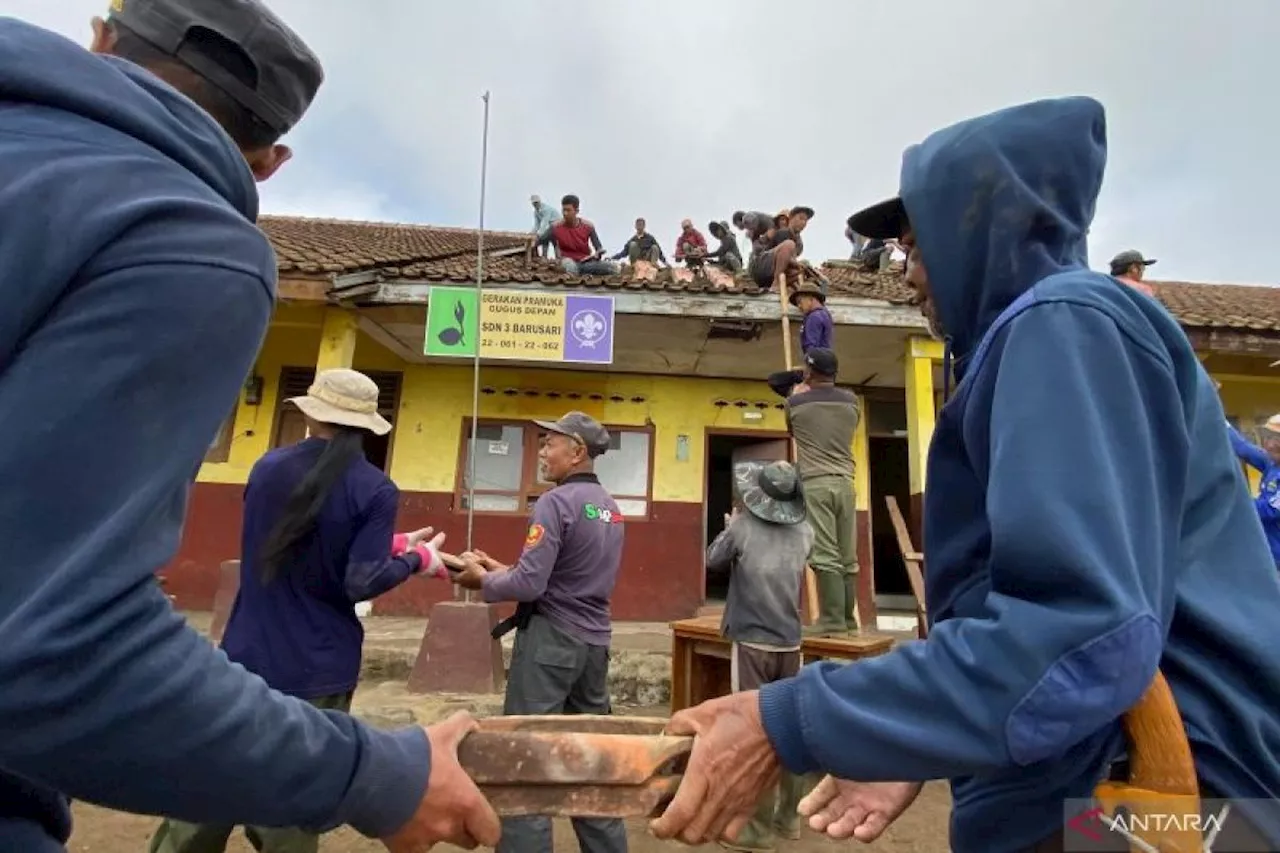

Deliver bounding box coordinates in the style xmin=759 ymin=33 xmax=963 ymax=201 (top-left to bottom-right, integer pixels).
xmin=799 ymin=776 xmax=922 ymax=844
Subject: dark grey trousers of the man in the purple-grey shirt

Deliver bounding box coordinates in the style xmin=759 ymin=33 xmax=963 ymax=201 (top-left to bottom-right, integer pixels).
xmin=497 ymin=615 xmax=627 ymax=853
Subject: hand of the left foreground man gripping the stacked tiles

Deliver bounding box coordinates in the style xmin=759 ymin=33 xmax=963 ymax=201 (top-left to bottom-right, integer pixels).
xmin=383 ymin=711 xmax=502 ymax=853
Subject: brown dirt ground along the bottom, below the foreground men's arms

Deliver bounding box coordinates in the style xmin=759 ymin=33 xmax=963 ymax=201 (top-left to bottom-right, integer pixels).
xmin=67 ymin=783 xmax=951 ymax=853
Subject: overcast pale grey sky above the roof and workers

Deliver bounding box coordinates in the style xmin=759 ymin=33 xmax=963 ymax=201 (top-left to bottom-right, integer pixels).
xmin=0 ymin=0 xmax=1280 ymax=283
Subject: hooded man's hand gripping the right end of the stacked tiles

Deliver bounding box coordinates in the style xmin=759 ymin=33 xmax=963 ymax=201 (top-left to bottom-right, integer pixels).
xmin=649 ymin=690 xmax=782 ymax=844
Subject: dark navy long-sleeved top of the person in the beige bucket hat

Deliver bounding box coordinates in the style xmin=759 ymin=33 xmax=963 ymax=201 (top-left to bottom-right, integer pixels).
xmin=223 ymin=438 xmax=422 ymax=699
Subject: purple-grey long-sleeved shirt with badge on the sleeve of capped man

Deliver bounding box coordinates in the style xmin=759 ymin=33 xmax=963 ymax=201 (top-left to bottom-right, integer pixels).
xmin=481 ymin=474 xmax=623 ymax=646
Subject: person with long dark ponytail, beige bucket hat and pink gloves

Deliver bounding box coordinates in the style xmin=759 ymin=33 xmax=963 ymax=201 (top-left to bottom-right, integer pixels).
xmin=150 ymin=369 xmax=448 ymax=853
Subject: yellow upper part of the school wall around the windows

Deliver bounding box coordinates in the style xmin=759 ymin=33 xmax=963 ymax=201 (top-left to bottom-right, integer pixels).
xmin=198 ymin=318 xmax=803 ymax=503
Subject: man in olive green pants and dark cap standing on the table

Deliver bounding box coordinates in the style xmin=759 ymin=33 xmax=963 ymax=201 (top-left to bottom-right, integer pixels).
xmin=787 ymin=348 xmax=859 ymax=634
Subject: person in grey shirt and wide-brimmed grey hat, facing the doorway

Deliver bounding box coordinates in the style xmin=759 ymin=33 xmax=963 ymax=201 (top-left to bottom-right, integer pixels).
xmin=707 ymin=462 xmax=813 ymax=852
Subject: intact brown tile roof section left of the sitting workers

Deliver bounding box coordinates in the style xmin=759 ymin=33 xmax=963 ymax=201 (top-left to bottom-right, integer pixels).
xmin=257 ymin=216 xmax=529 ymax=273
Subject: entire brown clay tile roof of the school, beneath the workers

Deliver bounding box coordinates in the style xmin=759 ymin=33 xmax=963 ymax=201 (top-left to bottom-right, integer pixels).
xmin=259 ymin=216 xmax=1280 ymax=334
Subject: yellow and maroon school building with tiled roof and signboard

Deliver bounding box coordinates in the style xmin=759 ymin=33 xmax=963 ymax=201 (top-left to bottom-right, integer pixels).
xmin=161 ymin=216 xmax=1280 ymax=624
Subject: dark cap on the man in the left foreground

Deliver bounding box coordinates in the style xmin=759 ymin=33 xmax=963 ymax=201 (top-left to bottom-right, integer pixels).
xmin=110 ymin=0 xmax=324 ymax=136
